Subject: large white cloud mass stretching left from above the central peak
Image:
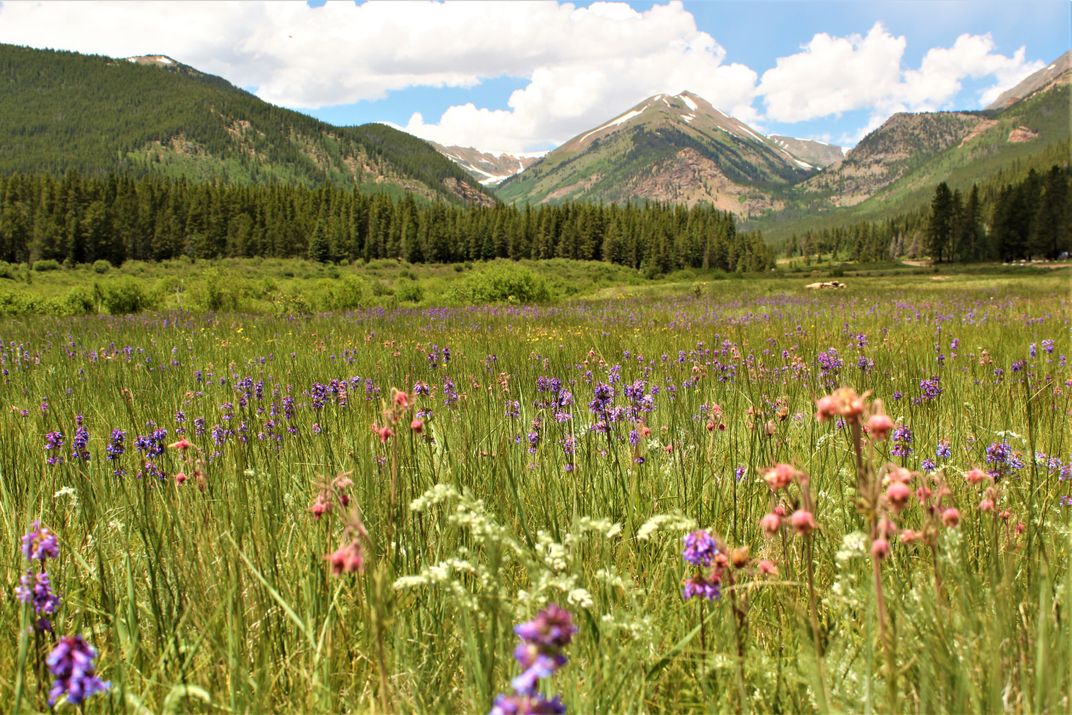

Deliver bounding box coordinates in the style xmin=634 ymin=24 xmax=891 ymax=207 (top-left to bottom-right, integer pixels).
xmin=0 ymin=2 xmax=758 ymax=151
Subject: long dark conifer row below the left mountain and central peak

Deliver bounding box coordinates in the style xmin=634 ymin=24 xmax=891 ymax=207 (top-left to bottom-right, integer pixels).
xmin=0 ymin=172 xmax=774 ymax=273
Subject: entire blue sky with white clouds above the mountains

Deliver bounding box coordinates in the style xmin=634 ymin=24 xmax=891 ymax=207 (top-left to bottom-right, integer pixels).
xmin=0 ymin=0 xmax=1072 ymax=152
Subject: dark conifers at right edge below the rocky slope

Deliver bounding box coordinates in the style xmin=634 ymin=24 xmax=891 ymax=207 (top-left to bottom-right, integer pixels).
xmin=786 ymin=164 xmax=1072 ymax=263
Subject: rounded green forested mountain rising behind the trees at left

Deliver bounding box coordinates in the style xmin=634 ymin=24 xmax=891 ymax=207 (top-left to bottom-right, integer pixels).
xmin=0 ymin=45 xmax=494 ymax=204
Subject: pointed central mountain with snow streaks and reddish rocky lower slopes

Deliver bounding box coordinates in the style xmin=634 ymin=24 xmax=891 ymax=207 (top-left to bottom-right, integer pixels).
xmin=496 ymin=92 xmax=816 ymax=215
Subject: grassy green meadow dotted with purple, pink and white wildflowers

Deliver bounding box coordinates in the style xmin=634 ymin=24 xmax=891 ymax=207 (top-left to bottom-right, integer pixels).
xmin=0 ymin=271 xmax=1072 ymax=713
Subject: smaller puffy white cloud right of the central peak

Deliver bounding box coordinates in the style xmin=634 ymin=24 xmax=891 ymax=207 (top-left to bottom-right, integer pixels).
xmin=758 ymin=24 xmax=1043 ymax=127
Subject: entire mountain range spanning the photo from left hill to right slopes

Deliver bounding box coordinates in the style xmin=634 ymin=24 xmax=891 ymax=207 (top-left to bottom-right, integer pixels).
xmin=0 ymin=45 xmax=1072 ymax=230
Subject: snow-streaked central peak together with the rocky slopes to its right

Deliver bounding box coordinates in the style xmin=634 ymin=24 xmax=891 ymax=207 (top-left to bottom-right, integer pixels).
xmin=482 ymin=54 xmax=1072 ymax=225
